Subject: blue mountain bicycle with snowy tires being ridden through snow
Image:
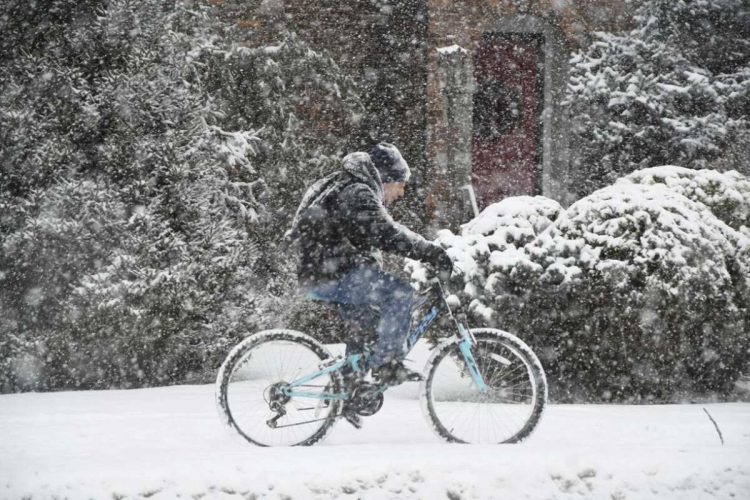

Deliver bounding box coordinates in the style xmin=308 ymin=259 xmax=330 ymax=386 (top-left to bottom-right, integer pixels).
xmin=216 ymin=279 xmax=547 ymax=446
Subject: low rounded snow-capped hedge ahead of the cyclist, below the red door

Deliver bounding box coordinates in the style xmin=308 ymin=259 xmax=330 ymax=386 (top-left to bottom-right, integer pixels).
xmin=410 ymin=169 xmax=750 ymax=400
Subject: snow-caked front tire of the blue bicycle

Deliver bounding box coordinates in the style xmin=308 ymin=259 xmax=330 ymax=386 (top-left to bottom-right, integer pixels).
xmin=420 ymin=328 xmax=548 ymax=444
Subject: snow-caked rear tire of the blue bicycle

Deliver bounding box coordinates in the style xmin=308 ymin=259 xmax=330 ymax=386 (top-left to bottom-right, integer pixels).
xmin=216 ymin=330 xmax=342 ymax=446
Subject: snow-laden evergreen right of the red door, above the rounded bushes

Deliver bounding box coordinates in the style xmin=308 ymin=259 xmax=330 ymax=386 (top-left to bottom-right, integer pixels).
xmin=566 ymin=0 xmax=750 ymax=195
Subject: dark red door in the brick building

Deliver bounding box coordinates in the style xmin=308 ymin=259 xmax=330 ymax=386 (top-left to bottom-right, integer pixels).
xmin=472 ymin=33 xmax=544 ymax=210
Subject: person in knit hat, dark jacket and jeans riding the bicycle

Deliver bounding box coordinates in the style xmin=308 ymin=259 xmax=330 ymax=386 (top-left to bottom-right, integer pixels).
xmin=290 ymin=142 xmax=453 ymax=385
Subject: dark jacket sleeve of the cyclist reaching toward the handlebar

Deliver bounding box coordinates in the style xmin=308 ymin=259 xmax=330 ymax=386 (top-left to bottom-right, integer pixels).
xmin=339 ymin=184 xmax=442 ymax=262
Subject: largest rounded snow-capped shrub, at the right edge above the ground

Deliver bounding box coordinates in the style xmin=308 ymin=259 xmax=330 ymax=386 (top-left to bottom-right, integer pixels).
xmin=527 ymin=185 xmax=749 ymax=397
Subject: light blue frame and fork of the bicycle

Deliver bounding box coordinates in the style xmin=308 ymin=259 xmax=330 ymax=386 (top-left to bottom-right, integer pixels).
xmin=282 ymin=279 xmax=487 ymax=400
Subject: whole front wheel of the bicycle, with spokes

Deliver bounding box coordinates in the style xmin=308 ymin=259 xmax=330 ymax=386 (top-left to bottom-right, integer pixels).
xmin=421 ymin=328 xmax=547 ymax=444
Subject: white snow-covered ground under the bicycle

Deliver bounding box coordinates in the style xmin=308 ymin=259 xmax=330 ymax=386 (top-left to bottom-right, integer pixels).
xmin=0 ymin=346 xmax=750 ymax=500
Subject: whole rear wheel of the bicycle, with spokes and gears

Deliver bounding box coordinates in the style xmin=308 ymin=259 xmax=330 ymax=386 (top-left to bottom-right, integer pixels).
xmin=216 ymin=330 xmax=341 ymax=446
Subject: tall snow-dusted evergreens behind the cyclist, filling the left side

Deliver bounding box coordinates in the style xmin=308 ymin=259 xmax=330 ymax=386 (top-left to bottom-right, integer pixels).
xmin=0 ymin=0 xmax=358 ymax=391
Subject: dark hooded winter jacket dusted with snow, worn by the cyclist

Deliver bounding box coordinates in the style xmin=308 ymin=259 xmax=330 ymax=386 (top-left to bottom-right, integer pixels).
xmin=290 ymin=153 xmax=442 ymax=285
